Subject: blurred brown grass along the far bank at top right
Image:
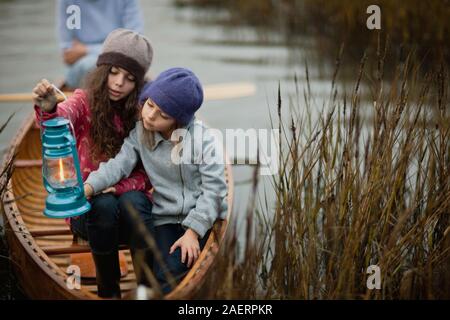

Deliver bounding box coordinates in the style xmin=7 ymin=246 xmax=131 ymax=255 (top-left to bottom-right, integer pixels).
xmin=173 ymin=0 xmax=450 ymax=64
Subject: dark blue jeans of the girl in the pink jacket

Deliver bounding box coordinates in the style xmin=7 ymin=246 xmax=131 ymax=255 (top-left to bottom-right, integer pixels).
xmin=71 ymin=191 xmax=154 ymax=254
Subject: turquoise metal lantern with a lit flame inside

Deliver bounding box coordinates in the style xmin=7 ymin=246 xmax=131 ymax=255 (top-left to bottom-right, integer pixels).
xmin=42 ymin=117 xmax=91 ymax=218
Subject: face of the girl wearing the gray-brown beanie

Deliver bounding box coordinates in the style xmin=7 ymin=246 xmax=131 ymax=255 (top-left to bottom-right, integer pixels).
xmin=108 ymin=66 xmax=136 ymax=101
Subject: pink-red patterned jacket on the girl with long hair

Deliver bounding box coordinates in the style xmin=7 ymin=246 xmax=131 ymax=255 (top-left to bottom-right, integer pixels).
xmin=34 ymin=89 xmax=152 ymax=206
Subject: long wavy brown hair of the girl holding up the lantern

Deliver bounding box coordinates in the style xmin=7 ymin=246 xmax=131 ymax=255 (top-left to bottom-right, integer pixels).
xmin=86 ymin=65 xmax=143 ymax=161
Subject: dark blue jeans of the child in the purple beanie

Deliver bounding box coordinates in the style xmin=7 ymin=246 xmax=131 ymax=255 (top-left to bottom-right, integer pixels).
xmin=153 ymin=224 xmax=210 ymax=293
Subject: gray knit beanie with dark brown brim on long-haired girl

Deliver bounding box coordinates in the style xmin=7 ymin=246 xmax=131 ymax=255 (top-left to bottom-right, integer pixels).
xmin=97 ymin=29 xmax=153 ymax=80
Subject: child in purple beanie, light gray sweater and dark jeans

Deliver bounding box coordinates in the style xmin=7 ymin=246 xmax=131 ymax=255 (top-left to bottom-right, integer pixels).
xmin=84 ymin=68 xmax=227 ymax=293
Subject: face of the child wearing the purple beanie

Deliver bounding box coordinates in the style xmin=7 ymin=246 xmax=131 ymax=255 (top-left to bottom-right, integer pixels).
xmin=142 ymin=98 xmax=176 ymax=138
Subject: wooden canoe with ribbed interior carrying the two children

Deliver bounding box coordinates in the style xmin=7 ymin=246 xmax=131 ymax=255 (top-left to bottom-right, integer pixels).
xmin=2 ymin=114 xmax=233 ymax=299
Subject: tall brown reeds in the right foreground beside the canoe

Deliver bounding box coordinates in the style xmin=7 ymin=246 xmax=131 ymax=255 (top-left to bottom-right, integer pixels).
xmin=198 ymin=48 xmax=450 ymax=299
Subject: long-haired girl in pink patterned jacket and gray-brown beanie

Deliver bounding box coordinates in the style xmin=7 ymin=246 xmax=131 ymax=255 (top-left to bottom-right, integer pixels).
xmin=33 ymin=29 xmax=153 ymax=298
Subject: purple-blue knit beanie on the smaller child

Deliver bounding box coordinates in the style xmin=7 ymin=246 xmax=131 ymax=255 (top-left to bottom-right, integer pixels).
xmin=139 ymin=68 xmax=203 ymax=125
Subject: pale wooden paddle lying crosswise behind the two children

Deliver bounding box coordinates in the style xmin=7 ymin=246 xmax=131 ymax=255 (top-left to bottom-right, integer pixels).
xmin=0 ymin=82 xmax=256 ymax=102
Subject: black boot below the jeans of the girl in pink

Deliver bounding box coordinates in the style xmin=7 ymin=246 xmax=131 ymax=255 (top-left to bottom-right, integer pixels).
xmin=92 ymin=251 xmax=121 ymax=299
